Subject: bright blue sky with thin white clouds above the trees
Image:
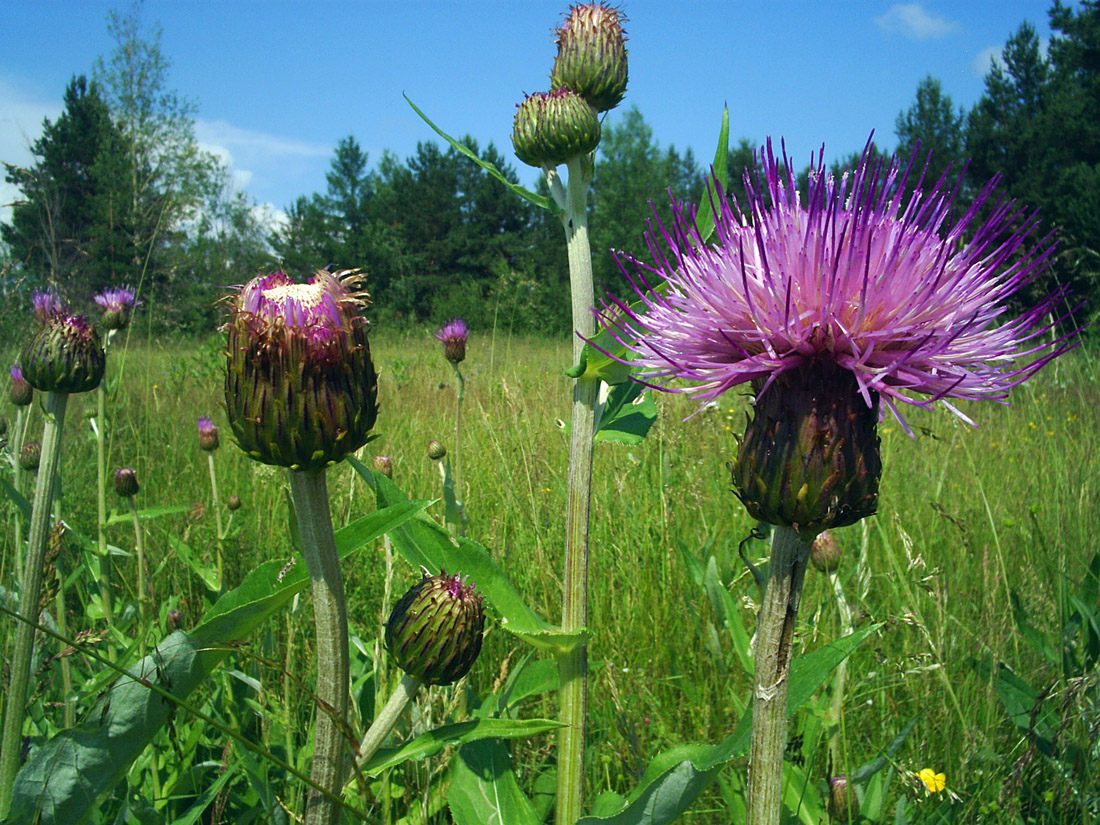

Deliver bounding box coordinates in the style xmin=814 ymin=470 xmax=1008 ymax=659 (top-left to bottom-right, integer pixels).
xmin=0 ymin=0 xmax=1064 ymax=229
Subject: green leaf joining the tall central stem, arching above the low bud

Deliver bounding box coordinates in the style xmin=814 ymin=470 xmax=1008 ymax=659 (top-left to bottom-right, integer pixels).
xmin=348 ymin=457 xmax=587 ymax=653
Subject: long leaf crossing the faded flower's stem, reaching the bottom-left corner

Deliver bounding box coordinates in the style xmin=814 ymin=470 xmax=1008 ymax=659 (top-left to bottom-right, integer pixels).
xmin=10 ymin=501 xmax=429 ymax=825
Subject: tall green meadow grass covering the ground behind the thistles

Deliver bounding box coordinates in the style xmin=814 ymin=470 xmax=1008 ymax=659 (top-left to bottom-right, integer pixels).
xmin=0 ymin=329 xmax=1100 ymax=823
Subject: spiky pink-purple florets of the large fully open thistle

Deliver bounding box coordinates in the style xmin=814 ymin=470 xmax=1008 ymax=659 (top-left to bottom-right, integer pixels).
xmin=597 ymin=141 xmax=1076 ymax=431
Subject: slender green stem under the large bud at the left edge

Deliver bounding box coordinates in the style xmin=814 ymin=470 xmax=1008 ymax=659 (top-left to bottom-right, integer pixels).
xmin=0 ymin=393 xmax=68 ymax=821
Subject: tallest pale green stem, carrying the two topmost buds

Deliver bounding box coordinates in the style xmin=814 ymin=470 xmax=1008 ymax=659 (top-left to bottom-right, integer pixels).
xmin=557 ymin=157 xmax=600 ymax=825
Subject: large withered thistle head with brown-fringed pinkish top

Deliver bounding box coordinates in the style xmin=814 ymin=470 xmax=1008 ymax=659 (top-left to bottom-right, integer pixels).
xmin=226 ymin=270 xmax=378 ymax=471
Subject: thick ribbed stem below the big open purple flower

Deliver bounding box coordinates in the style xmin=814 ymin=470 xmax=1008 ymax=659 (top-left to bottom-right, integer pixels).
xmin=745 ymin=527 xmax=810 ymax=825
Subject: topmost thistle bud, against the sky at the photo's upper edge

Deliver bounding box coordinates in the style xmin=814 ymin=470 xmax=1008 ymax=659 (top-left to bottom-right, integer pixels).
xmin=550 ymin=3 xmax=628 ymax=112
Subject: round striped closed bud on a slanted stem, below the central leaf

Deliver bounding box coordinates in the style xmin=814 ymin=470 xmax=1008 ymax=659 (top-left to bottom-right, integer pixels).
xmin=386 ymin=571 xmax=485 ymax=684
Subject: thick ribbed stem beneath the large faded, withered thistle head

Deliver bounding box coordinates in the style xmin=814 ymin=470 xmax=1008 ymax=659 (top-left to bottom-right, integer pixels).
xmin=288 ymin=470 xmax=350 ymax=825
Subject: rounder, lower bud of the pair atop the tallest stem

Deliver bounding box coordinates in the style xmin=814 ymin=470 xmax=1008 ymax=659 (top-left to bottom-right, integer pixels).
xmin=512 ymin=89 xmax=600 ymax=167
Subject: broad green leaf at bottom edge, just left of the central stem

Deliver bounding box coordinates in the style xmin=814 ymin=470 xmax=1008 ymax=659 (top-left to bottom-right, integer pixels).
xmin=447 ymin=739 xmax=539 ymax=825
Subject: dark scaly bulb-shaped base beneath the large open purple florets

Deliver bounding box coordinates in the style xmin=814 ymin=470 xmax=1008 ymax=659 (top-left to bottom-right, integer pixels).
xmin=733 ymin=363 xmax=882 ymax=541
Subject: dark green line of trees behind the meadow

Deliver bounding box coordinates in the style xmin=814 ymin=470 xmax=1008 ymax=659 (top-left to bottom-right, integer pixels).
xmin=0 ymin=0 xmax=1100 ymax=332
